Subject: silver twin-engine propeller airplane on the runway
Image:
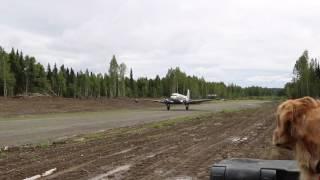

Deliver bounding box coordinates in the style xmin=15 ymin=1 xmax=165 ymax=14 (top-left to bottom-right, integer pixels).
xmin=153 ymin=89 xmax=212 ymax=111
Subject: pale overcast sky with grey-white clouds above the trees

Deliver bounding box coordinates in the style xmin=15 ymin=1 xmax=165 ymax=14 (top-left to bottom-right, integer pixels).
xmin=0 ymin=0 xmax=320 ymax=87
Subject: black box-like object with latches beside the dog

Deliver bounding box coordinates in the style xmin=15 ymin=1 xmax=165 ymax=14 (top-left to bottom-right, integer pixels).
xmin=210 ymin=159 xmax=299 ymax=180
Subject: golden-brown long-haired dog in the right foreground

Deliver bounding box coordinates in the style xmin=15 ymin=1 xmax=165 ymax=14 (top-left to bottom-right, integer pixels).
xmin=273 ymin=97 xmax=320 ymax=180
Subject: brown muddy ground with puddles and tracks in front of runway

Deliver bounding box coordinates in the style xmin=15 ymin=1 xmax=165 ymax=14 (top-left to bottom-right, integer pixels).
xmin=0 ymin=103 xmax=292 ymax=180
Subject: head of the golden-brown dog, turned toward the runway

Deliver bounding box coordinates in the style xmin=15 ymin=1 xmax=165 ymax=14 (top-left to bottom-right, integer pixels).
xmin=273 ymin=97 xmax=318 ymax=150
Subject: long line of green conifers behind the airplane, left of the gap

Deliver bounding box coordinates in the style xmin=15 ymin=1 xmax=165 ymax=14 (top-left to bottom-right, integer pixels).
xmin=0 ymin=47 xmax=280 ymax=98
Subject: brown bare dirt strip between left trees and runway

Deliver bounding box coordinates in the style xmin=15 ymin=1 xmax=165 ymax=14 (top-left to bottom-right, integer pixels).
xmin=0 ymin=96 xmax=160 ymax=116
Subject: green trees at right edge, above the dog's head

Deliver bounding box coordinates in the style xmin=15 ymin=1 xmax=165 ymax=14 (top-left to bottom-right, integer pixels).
xmin=285 ymin=51 xmax=320 ymax=98
